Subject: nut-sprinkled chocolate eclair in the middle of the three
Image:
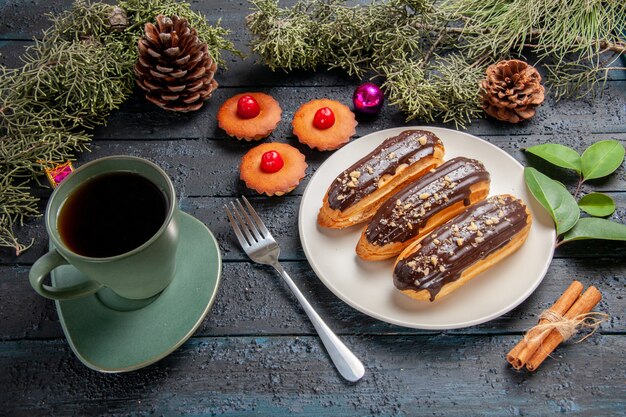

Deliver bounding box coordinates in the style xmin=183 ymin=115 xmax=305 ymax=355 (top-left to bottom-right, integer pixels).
xmin=356 ymin=157 xmax=490 ymax=261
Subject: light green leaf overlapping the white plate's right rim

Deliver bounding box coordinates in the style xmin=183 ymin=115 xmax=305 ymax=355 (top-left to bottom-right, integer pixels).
xmin=524 ymin=167 xmax=580 ymax=235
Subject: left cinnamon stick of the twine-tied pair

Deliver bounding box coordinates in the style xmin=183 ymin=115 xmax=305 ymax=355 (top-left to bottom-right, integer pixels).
xmin=506 ymin=281 xmax=583 ymax=370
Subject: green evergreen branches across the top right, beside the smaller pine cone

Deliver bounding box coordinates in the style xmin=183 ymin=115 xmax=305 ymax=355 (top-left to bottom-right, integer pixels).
xmin=247 ymin=0 xmax=626 ymax=126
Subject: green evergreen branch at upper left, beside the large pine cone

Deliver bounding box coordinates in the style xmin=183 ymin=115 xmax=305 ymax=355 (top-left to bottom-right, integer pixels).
xmin=0 ymin=0 xmax=238 ymax=254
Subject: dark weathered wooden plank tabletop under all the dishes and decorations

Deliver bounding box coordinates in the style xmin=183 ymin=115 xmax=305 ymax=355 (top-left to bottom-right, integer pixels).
xmin=0 ymin=0 xmax=626 ymax=416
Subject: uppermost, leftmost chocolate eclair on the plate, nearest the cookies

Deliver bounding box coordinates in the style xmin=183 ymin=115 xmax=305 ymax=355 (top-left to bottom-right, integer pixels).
xmin=317 ymin=130 xmax=444 ymax=229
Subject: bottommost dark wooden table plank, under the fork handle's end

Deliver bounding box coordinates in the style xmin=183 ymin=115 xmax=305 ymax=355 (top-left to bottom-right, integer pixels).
xmin=0 ymin=334 xmax=626 ymax=417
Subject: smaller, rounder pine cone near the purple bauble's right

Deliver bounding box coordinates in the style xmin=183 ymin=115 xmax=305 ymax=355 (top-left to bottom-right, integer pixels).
xmin=482 ymin=59 xmax=545 ymax=123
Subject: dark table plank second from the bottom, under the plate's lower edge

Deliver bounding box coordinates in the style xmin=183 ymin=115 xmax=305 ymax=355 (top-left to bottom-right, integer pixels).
xmin=0 ymin=255 xmax=626 ymax=340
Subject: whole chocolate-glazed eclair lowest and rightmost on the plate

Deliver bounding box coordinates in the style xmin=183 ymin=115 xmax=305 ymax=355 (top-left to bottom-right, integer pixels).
xmin=393 ymin=195 xmax=532 ymax=301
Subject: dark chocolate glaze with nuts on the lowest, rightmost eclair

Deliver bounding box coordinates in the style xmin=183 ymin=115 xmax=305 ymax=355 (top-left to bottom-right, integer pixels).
xmin=393 ymin=195 xmax=528 ymax=301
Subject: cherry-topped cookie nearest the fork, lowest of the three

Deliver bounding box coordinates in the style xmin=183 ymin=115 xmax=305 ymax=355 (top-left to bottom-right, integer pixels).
xmin=239 ymin=143 xmax=308 ymax=196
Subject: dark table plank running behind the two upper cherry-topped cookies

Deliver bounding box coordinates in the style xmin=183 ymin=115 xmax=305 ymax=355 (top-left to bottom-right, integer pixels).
xmin=90 ymin=85 xmax=626 ymax=140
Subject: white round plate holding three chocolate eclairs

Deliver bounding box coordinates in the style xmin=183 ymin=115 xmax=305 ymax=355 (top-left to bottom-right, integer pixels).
xmin=298 ymin=127 xmax=556 ymax=330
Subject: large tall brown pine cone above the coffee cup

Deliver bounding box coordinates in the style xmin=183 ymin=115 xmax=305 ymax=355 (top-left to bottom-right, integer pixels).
xmin=135 ymin=15 xmax=218 ymax=112
